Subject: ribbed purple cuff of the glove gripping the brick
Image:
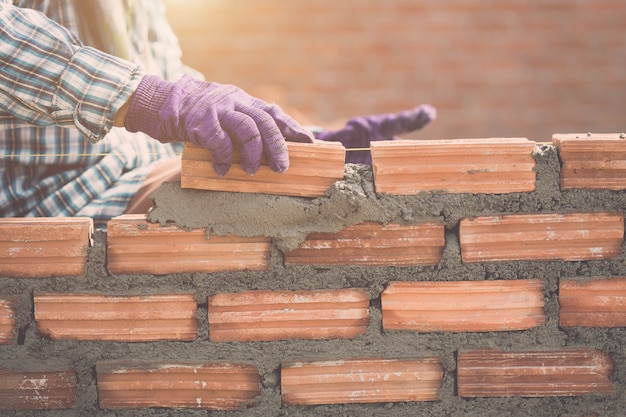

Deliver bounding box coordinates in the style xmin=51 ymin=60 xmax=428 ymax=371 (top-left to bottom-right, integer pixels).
xmin=124 ymin=75 xmax=173 ymax=142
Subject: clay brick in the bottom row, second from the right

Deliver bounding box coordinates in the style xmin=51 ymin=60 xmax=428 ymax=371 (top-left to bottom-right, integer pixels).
xmin=281 ymin=358 xmax=443 ymax=405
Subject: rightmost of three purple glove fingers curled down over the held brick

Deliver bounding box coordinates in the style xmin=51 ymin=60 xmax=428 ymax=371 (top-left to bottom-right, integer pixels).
xmin=238 ymin=106 xmax=289 ymax=172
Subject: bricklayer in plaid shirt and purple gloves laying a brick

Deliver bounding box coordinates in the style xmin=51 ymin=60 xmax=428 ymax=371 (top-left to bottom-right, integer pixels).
xmin=0 ymin=0 xmax=435 ymax=226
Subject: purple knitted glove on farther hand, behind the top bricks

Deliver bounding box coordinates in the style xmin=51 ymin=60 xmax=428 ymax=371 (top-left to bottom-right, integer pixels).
xmin=315 ymin=104 xmax=437 ymax=165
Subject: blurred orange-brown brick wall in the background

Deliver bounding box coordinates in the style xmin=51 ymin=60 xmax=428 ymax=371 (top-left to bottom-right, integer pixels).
xmin=165 ymin=0 xmax=626 ymax=141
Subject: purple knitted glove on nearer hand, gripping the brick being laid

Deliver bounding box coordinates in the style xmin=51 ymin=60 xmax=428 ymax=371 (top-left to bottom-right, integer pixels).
xmin=124 ymin=75 xmax=313 ymax=175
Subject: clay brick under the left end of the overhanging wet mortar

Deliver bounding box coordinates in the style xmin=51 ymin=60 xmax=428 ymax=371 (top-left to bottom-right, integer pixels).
xmin=107 ymin=215 xmax=271 ymax=275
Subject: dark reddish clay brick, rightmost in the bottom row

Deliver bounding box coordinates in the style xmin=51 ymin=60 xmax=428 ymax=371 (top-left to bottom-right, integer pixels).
xmin=457 ymin=348 xmax=613 ymax=397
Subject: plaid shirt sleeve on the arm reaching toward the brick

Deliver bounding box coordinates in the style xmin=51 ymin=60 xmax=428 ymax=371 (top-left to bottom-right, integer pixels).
xmin=0 ymin=3 xmax=144 ymax=141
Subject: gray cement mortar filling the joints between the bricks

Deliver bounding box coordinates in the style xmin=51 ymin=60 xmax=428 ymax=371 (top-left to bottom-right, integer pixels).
xmin=0 ymin=145 xmax=626 ymax=417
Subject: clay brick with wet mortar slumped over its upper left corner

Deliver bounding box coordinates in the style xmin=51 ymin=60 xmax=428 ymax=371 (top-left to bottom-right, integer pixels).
xmin=284 ymin=220 xmax=445 ymax=266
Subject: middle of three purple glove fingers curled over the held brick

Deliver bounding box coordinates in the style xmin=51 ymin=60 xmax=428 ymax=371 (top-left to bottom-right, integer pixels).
xmin=220 ymin=110 xmax=263 ymax=175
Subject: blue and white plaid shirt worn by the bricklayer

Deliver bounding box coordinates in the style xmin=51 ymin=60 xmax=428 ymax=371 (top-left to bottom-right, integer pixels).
xmin=0 ymin=0 xmax=190 ymax=227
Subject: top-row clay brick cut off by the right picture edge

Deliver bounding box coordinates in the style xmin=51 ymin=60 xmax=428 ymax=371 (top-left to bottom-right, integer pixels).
xmin=552 ymin=133 xmax=626 ymax=190
